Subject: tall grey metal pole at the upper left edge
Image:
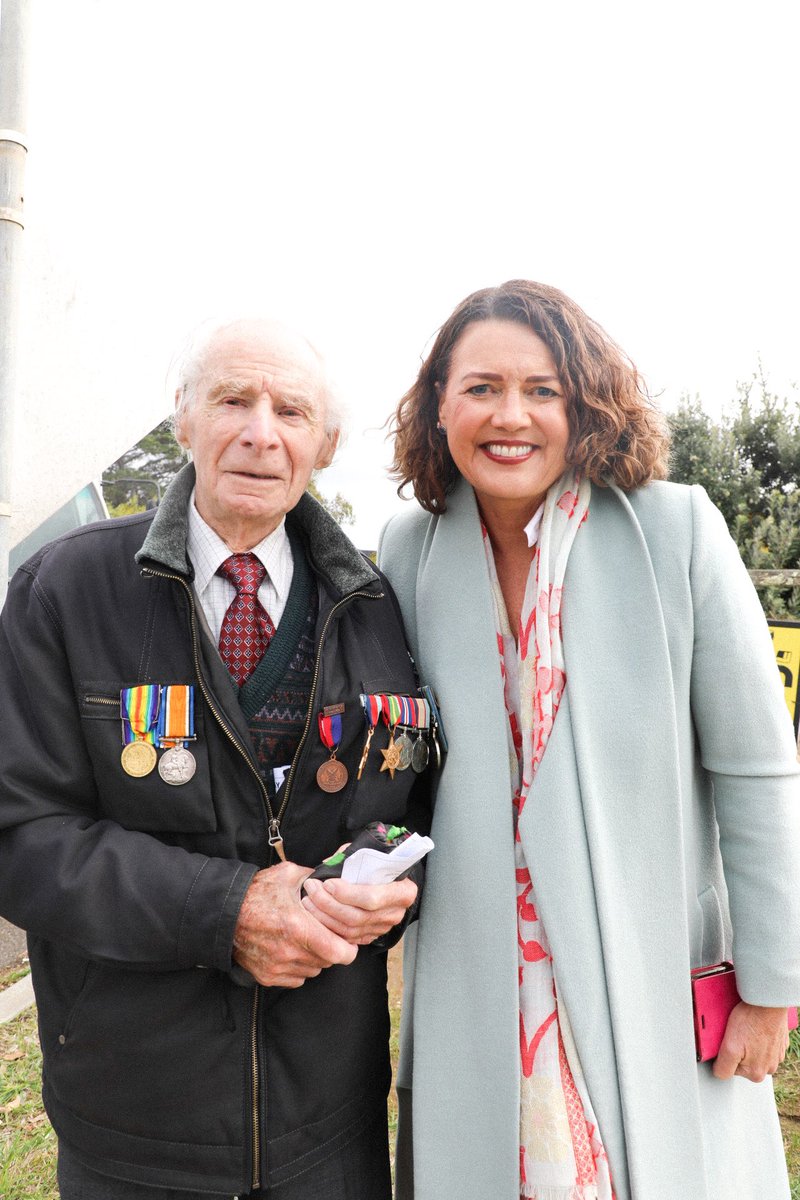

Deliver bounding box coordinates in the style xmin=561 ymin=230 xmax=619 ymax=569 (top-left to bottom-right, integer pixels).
xmin=0 ymin=0 xmax=29 ymax=605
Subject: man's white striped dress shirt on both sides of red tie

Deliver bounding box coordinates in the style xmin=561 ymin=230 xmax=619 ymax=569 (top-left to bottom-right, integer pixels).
xmin=186 ymin=492 xmax=294 ymax=643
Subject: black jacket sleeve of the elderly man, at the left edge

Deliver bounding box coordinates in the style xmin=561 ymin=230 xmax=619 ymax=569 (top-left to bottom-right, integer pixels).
xmin=0 ymin=568 xmax=257 ymax=971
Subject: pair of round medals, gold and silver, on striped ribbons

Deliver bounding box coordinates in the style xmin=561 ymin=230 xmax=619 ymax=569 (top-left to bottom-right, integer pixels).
xmin=120 ymin=683 xmax=197 ymax=787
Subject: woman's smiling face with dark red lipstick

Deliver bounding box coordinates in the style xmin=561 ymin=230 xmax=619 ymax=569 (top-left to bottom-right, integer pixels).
xmin=439 ymin=319 xmax=570 ymax=516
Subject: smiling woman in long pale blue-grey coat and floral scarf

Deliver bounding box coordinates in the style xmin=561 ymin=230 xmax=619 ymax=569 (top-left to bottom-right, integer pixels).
xmin=380 ymin=280 xmax=800 ymax=1200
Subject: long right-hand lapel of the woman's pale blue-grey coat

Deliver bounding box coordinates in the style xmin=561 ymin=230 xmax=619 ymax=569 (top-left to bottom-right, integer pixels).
xmin=521 ymin=488 xmax=703 ymax=1200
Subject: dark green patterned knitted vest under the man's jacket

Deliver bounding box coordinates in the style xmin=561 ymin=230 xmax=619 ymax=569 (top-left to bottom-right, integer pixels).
xmin=239 ymin=530 xmax=318 ymax=777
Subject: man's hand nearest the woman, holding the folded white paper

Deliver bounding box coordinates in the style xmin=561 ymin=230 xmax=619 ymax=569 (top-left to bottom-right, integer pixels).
xmin=302 ymin=880 xmax=416 ymax=946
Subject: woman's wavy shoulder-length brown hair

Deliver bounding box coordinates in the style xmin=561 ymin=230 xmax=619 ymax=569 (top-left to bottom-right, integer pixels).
xmin=391 ymin=280 xmax=669 ymax=512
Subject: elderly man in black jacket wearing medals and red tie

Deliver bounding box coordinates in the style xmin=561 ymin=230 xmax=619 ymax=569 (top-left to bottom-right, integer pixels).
xmin=0 ymin=320 xmax=425 ymax=1200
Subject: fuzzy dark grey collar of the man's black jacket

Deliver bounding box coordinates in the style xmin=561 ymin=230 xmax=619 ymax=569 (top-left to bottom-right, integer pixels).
xmin=136 ymin=462 xmax=381 ymax=595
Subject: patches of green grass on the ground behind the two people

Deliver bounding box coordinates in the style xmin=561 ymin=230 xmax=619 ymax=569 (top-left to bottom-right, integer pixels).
xmin=0 ymin=950 xmax=800 ymax=1200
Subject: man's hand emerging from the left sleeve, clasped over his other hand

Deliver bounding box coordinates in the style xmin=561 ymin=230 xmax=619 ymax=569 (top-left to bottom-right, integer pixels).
xmin=234 ymin=863 xmax=357 ymax=988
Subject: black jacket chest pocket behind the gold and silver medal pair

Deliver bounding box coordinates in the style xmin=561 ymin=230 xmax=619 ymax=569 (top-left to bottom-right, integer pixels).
xmin=78 ymin=680 xmax=217 ymax=834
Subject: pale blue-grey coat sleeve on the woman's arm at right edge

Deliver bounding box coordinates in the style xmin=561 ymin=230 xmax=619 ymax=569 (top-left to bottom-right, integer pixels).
xmin=691 ymin=487 xmax=800 ymax=1006
